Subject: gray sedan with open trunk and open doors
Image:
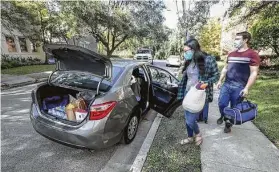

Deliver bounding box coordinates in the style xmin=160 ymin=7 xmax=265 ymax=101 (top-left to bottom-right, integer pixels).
xmin=30 ymin=45 xmax=181 ymax=149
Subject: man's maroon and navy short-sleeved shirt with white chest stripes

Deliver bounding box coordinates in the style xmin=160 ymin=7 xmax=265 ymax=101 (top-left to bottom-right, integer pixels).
xmin=225 ymin=49 xmax=260 ymax=87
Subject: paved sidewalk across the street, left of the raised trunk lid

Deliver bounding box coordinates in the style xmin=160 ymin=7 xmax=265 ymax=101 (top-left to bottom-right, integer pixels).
xmin=1 ymin=71 xmax=51 ymax=89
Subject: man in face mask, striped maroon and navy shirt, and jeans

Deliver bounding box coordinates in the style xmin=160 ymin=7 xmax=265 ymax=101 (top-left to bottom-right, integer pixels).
xmin=217 ymin=32 xmax=260 ymax=133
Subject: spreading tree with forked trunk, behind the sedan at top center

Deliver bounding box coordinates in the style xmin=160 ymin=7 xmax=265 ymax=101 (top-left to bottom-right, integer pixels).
xmin=61 ymin=0 xmax=164 ymax=57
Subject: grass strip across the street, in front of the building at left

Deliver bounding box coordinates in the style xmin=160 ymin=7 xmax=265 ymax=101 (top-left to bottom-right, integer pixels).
xmin=1 ymin=65 xmax=55 ymax=75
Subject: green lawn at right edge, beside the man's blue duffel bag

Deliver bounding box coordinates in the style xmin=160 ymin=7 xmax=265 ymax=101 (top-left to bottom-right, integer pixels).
xmin=252 ymin=70 xmax=279 ymax=147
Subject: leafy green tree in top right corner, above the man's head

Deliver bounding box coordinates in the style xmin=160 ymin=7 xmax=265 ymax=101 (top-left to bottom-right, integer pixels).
xmin=229 ymin=1 xmax=279 ymax=56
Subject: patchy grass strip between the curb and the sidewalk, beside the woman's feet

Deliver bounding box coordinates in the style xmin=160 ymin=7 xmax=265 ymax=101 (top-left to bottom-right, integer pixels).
xmin=143 ymin=107 xmax=201 ymax=172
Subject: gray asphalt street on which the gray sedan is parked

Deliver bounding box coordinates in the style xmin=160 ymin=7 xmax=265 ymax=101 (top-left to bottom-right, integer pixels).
xmin=1 ymin=60 xmax=180 ymax=172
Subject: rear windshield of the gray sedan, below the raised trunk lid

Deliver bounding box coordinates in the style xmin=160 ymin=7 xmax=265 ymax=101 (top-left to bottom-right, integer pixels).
xmin=51 ymin=66 xmax=124 ymax=92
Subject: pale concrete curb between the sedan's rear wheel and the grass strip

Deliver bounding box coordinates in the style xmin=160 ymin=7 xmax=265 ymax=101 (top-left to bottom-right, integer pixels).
xmin=130 ymin=114 xmax=163 ymax=172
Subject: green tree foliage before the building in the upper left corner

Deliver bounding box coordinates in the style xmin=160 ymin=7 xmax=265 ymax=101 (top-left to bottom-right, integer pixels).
xmin=1 ymin=1 xmax=81 ymax=43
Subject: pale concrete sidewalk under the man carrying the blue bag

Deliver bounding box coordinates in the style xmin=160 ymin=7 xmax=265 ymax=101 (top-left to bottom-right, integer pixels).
xmin=200 ymin=92 xmax=279 ymax=172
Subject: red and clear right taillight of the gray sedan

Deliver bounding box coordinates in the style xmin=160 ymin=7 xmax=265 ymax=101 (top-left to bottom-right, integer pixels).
xmin=89 ymin=102 xmax=116 ymax=120
